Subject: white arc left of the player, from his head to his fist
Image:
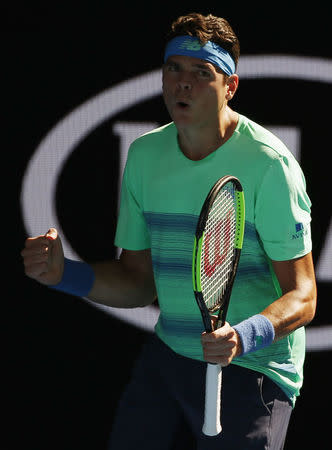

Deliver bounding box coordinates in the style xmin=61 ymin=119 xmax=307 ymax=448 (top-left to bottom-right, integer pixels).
xmin=21 ymin=70 xmax=161 ymax=259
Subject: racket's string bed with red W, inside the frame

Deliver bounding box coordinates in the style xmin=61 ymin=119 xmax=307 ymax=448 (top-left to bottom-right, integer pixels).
xmin=200 ymin=183 xmax=236 ymax=311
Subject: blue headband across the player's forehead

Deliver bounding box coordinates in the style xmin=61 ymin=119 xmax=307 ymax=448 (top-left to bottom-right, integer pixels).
xmin=164 ymin=35 xmax=235 ymax=75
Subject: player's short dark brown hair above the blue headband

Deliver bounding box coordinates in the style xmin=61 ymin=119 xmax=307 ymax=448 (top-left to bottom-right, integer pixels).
xmin=167 ymin=13 xmax=240 ymax=66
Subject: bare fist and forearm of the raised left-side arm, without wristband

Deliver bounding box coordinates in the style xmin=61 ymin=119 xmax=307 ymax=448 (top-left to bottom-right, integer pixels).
xmin=21 ymin=228 xmax=156 ymax=308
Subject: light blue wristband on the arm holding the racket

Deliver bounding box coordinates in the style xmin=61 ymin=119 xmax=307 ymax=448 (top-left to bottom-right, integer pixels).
xmin=233 ymin=314 xmax=275 ymax=356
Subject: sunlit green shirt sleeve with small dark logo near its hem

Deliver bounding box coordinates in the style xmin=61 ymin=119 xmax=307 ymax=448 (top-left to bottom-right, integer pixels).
xmin=255 ymin=155 xmax=312 ymax=261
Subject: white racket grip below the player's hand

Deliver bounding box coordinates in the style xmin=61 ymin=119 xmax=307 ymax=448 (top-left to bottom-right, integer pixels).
xmin=203 ymin=364 xmax=222 ymax=436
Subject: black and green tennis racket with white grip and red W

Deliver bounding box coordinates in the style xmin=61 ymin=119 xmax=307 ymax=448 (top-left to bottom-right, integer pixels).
xmin=192 ymin=175 xmax=245 ymax=436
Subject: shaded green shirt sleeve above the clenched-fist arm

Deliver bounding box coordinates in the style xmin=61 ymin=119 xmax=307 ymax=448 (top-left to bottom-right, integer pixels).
xmin=115 ymin=144 xmax=150 ymax=250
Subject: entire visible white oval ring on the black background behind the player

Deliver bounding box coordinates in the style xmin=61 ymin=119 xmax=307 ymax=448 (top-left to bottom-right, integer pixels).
xmin=21 ymin=55 xmax=332 ymax=350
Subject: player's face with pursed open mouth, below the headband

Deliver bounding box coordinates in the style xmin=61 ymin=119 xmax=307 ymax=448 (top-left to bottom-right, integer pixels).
xmin=163 ymin=55 xmax=228 ymax=128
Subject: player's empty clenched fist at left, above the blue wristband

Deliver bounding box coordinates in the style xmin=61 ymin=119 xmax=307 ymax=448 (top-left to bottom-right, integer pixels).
xmin=21 ymin=228 xmax=64 ymax=285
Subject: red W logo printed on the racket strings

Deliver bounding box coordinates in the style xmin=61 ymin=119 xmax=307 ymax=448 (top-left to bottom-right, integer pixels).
xmin=204 ymin=211 xmax=232 ymax=278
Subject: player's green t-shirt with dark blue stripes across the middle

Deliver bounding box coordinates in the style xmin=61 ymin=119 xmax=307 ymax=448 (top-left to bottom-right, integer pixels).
xmin=115 ymin=115 xmax=311 ymax=402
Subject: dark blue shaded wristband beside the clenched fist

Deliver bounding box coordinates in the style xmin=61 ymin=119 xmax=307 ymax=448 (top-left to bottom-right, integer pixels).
xmin=49 ymin=258 xmax=95 ymax=297
